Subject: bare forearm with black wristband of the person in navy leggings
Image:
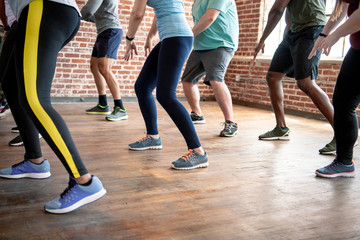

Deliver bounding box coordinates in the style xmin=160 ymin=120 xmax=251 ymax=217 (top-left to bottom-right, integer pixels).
xmin=124 ymin=0 xmax=147 ymax=61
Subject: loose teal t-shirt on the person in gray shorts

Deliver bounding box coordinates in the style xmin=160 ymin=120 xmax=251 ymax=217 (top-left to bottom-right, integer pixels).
xmin=192 ymin=0 xmax=239 ymax=50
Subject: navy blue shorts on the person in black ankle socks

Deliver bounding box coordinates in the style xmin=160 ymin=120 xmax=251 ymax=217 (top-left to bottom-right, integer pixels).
xmin=91 ymin=28 xmax=123 ymax=59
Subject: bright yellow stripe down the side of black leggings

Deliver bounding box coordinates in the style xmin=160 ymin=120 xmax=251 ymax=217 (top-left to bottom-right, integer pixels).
xmin=24 ymin=0 xmax=80 ymax=178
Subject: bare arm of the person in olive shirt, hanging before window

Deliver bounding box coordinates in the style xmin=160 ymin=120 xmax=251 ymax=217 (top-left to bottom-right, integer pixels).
xmin=253 ymin=0 xmax=290 ymax=61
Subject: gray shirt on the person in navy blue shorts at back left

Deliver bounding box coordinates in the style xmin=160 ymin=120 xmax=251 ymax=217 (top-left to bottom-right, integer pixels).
xmin=81 ymin=0 xmax=122 ymax=34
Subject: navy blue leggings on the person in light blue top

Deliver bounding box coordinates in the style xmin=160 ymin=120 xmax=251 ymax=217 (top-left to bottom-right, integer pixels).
xmin=135 ymin=37 xmax=201 ymax=149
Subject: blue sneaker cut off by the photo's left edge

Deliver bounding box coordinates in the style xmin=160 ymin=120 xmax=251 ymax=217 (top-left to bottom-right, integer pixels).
xmin=0 ymin=160 xmax=51 ymax=179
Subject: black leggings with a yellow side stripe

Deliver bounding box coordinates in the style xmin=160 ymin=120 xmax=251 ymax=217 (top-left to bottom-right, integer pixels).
xmin=3 ymin=0 xmax=88 ymax=178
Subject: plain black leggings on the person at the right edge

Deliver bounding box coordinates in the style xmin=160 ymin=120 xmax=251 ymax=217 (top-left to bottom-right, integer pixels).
xmin=333 ymin=48 xmax=360 ymax=165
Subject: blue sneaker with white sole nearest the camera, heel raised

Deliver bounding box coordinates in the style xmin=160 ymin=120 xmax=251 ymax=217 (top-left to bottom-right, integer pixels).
xmin=45 ymin=176 xmax=106 ymax=213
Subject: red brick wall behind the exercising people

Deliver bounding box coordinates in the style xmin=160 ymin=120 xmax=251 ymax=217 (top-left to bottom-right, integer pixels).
xmin=52 ymin=0 xmax=354 ymax=120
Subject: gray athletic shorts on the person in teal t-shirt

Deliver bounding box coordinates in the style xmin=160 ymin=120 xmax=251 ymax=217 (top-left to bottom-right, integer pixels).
xmin=181 ymin=47 xmax=235 ymax=85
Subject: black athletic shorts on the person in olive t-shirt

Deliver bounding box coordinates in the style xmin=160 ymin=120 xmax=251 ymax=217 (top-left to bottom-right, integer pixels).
xmin=269 ymin=26 xmax=324 ymax=80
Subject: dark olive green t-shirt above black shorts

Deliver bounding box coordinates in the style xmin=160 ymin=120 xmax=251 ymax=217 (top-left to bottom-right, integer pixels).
xmin=287 ymin=0 xmax=327 ymax=32
